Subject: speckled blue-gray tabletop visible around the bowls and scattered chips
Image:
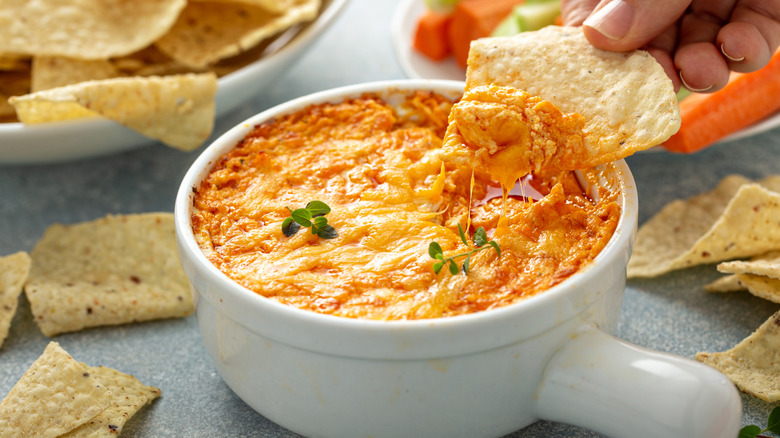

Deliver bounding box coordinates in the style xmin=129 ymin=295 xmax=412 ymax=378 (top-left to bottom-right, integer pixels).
xmin=0 ymin=0 xmax=780 ymax=438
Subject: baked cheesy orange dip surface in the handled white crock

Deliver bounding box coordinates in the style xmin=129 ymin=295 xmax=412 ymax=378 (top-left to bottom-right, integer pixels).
xmin=192 ymin=92 xmax=620 ymax=320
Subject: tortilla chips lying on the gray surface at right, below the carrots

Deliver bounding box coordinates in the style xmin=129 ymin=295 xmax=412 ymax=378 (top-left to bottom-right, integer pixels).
xmin=628 ymin=175 xmax=780 ymax=402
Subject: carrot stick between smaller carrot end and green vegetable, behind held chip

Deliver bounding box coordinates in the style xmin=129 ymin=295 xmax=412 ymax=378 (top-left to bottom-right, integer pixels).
xmin=448 ymin=0 xmax=523 ymax=67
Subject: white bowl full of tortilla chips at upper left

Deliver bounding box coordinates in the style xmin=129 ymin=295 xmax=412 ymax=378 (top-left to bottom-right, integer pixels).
xmin=0 ymin=0 xmax=347 ymax=164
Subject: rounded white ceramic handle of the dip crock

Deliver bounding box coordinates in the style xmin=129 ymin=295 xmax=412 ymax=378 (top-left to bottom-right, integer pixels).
xmin=536 ymin=326 xmax=742 ymax=438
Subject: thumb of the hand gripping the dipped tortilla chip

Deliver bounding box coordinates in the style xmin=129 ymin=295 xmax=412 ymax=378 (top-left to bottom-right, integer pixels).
xmin=582 ymin=0 xmax=691 ymax=51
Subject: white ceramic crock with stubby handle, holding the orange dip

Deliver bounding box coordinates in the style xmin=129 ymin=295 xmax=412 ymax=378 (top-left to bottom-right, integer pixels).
xmin=175 ymin=80 xmax=741 ymax=438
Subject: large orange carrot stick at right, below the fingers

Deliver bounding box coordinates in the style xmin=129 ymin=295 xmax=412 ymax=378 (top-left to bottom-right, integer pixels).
xmin=664 ymin=51 xmax=780 ymax=153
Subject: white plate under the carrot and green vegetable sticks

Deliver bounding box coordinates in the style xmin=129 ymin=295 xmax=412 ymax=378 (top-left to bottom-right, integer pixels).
xmin=392 ymin=0 xmax=780 ymax=151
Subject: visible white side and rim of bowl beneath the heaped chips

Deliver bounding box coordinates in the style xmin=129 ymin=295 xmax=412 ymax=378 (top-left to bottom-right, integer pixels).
xmin=0 ymin=0 xmax=348 ymax=164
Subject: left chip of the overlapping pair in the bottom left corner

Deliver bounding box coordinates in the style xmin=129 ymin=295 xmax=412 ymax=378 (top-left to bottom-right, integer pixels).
xmin=0 ymin=342 xmax=111 ymax=438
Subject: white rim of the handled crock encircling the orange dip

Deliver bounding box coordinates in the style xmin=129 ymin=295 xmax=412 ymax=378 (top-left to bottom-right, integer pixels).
xmin=174 ymin=79 xmax=638 ymax=358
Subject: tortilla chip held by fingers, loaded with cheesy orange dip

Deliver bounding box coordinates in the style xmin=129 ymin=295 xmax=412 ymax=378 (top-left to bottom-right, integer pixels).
xmin=442 ymin=26 xmax=680 ymax=185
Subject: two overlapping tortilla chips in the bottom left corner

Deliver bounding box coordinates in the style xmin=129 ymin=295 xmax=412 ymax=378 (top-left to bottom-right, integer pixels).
xmin=0 ymin=342 xmax=160 ymax=438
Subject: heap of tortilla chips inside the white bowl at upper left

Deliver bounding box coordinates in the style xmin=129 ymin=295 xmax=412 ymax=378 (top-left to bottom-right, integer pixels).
xmin=0 ymin=0 xmax=321 ymax=150
